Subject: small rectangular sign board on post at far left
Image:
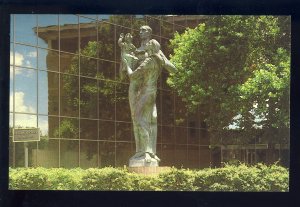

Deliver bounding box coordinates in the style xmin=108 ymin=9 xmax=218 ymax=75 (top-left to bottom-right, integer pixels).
xmin=13 ymin=128 xmax=40 ymax=142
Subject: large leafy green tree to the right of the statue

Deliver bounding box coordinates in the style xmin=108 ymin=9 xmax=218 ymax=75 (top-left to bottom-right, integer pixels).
xmin=168 ymin=16 xmax=290 ymax=142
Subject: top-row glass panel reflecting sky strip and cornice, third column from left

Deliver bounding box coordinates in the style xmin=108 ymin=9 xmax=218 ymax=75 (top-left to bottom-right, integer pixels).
xmin=59 ymin=15 xmax=79 ymax=53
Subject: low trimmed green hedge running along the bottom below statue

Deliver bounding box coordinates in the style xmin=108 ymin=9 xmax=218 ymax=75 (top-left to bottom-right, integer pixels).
xmin=9 ymin=164 xmax=289 ymax=191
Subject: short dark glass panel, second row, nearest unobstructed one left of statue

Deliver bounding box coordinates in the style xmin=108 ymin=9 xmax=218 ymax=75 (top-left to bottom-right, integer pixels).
xmin=97 ymin=60 xmax=115 ymax=80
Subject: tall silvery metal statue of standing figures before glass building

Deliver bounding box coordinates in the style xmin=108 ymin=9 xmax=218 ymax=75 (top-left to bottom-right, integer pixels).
xmin=122 ymin=26 xmax=175 ymax=167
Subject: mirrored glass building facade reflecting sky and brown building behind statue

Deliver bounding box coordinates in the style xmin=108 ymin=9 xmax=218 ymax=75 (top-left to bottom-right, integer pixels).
xmin=9 ymin=14 xmax=289 ymax=168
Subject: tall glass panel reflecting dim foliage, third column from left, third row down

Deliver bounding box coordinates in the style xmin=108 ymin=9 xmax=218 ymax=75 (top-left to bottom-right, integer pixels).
xmin=60 ymin=75 xmax=79 ymax=116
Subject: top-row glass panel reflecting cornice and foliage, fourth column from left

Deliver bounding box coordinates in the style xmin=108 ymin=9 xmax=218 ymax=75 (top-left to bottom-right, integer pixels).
xmin=79 ymin=17 xmax=98 ymax=51
